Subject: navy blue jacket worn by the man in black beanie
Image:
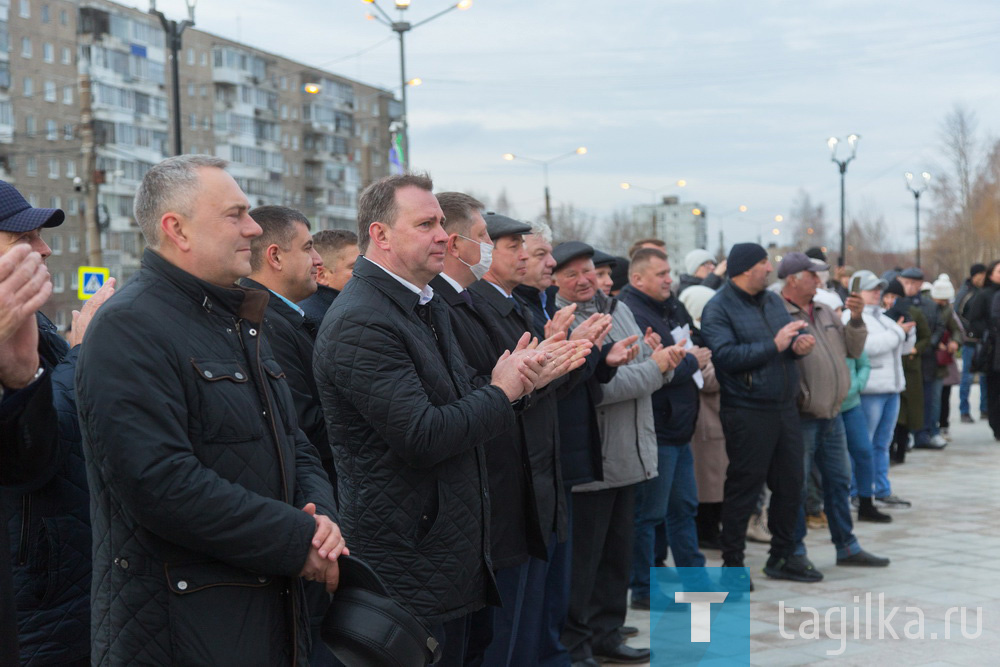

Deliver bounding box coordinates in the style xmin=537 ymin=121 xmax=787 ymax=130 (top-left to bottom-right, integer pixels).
xmin=701 ymin=281 xmax=799 ymax=411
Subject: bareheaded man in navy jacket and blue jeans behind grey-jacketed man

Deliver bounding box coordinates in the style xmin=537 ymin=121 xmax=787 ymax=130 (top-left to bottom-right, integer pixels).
xmin=618 ymin=248 xmax=711 ymax=609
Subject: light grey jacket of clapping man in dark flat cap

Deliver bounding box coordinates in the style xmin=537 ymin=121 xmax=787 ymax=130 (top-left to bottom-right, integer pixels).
xmin=556 ymin=292 xmax=672 ymax=492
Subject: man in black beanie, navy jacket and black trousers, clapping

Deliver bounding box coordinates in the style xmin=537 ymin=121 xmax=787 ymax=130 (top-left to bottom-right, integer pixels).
xmin=701 ymin=243 xmax=816 ymax=591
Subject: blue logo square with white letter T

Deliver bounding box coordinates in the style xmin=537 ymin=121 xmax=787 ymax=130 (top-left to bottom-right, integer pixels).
xmin=649 ymin=567 xmax=751 ymax=667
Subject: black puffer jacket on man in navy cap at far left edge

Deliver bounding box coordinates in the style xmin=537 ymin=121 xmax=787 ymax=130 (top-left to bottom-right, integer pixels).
xmin=3 ymin=313 xmax=91 ymax=665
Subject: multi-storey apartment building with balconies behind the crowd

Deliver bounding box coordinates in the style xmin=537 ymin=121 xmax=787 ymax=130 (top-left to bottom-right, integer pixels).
xmin=0 ymin=0 xmax=399 ymax=329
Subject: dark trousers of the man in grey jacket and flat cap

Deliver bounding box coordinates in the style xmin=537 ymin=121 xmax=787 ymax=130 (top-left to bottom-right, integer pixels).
xmin=562 ymin=486 xmax=632 ymax=661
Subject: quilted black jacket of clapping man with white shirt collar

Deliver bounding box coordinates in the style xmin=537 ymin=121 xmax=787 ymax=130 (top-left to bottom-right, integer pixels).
xmin=315 ymin=258 xmax=514 ymax=625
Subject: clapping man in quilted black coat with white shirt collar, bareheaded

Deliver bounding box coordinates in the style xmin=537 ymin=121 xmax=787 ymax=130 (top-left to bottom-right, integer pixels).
xmin=314 ymin=174 xmax=546 ymax=664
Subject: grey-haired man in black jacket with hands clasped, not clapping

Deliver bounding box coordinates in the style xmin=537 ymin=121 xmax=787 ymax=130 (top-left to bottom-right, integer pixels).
xmin=76 ymin=155 xmax=345 ymax=665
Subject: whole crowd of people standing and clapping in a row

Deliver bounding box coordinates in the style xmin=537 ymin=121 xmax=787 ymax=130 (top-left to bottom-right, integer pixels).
xmin=0 ymin=155 xmax=1000 ymax=666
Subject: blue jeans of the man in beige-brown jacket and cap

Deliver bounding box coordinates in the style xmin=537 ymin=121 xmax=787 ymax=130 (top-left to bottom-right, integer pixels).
xmin=795 ymin=415 xmax=861 ymax=558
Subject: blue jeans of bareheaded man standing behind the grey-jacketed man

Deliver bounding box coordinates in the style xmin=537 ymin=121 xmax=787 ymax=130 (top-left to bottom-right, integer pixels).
xmin=632 ymin=444 xmax=705 ymax=598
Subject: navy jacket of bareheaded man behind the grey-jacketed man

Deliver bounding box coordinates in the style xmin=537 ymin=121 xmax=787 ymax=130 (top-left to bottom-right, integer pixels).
xmin=618 ymin=285 xmax=699 ymax=445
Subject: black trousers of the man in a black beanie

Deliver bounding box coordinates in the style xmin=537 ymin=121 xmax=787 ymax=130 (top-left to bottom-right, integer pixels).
xmin=719 ymin=406 xmax=804 ymax=563
